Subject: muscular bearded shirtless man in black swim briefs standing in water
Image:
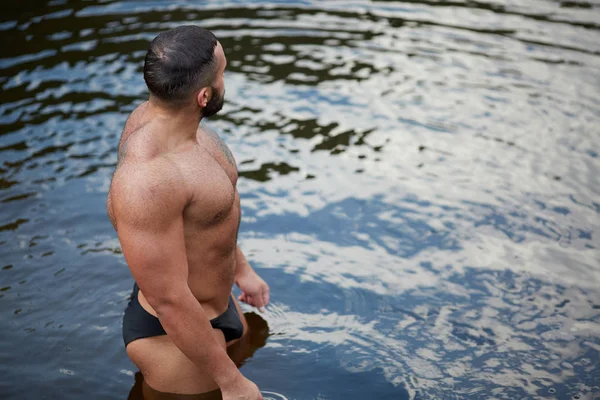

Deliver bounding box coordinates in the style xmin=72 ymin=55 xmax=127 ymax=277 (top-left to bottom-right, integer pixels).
xmin=107 ymin=26 xmax=269 ymax=400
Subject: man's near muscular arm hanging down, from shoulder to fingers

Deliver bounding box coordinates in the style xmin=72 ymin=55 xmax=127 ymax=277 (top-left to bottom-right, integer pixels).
xmin=111 ymin=166 xmax=262 ymax=400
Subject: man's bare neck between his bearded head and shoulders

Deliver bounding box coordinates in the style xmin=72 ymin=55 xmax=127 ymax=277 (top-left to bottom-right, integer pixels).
xmin=148 ymin=96 xmax=202 ymax=141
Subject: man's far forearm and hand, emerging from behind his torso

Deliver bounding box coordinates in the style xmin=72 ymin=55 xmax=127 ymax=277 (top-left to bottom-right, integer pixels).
xmin=235 ymin=246 xmax=270 ymax=312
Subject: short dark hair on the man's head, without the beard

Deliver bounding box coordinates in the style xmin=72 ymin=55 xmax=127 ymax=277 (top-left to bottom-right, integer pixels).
xmin=144 ymin=25 xmax=217 ymax=103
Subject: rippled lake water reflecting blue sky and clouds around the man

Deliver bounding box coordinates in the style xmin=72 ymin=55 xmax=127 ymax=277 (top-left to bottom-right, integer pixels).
xmin=0 ymin=0 xmax=600 ymax=400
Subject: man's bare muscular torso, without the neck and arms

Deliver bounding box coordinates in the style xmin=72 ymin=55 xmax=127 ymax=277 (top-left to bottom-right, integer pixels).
xmin=107 ymin=103 xmax=241 ymax=318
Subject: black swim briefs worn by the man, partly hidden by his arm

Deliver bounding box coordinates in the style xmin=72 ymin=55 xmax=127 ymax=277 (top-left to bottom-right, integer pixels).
xmin=123 ymin=283 xmax=244 ymax=346
